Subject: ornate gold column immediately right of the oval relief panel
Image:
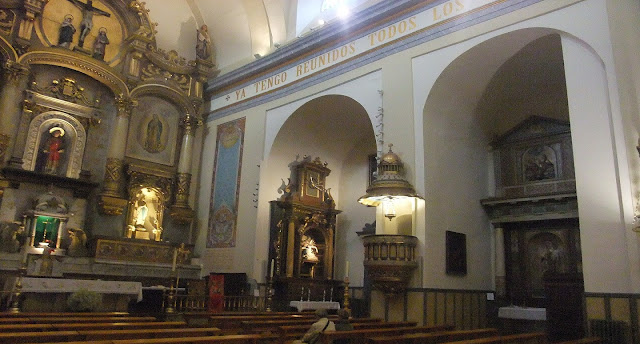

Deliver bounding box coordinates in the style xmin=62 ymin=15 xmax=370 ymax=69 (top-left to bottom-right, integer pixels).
xmin=171 ymin=114 xmax=202 ymax=223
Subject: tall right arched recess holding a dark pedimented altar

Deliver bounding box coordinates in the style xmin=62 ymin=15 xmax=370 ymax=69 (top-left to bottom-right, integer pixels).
xmin=424 ymin=29 xmax=581 ymax=305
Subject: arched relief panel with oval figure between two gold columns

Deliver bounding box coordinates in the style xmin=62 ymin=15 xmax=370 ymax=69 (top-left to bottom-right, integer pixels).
xmin=126 ymin=96 xmax=180 ymax=166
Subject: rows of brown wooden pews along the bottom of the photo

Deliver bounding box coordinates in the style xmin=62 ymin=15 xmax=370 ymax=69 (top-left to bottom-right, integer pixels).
xmin=0 ymin=313 xmax=599 ymax=344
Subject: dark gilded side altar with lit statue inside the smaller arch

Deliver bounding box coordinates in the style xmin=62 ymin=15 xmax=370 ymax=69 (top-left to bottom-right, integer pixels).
xmin=269 ymin=156 xmax=344 ymax=311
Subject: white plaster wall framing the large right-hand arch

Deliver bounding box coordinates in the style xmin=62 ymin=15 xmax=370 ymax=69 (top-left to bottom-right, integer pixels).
xmin=413 ymin=0 xmax=637 ymax=292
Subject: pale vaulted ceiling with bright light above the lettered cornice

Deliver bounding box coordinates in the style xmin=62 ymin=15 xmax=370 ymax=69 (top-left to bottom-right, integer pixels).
xmin=145 ymin=0 xmax=381 ymax=73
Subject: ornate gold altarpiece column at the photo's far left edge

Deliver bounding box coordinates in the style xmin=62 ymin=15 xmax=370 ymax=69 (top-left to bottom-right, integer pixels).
xmin=0 ymin=61 xmax=30 ymax=165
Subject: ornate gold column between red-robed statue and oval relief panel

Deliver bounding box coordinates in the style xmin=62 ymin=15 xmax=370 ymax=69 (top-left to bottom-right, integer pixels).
xmin=98 ymin=95 xmax=138 ymax=215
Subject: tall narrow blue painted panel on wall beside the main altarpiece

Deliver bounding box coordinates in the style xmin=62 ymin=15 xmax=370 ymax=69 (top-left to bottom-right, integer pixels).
xmin=207 ymin=117 xmax=246 ymax=248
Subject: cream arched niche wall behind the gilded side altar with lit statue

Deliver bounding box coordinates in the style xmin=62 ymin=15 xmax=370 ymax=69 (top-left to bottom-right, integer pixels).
xmin=256 ymin=95 xmax=376 ymax=283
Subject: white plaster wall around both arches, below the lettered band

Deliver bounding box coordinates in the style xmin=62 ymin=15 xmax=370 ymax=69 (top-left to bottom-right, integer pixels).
xmin=199 ymin=0 xmax=639 ymax=292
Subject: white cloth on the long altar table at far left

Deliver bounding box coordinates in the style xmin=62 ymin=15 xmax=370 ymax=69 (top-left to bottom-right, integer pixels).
xmin=22 ymin=277 xmax=142 ymax=302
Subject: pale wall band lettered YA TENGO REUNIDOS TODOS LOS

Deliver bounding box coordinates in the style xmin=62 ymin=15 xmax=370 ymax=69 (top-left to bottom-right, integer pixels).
xmin=210 ymin=0 xmax=504 ymax=112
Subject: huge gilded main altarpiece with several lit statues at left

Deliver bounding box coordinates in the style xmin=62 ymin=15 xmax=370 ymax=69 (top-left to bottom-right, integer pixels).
xmin=0 ymin=0 xmax=216 ymax=282
